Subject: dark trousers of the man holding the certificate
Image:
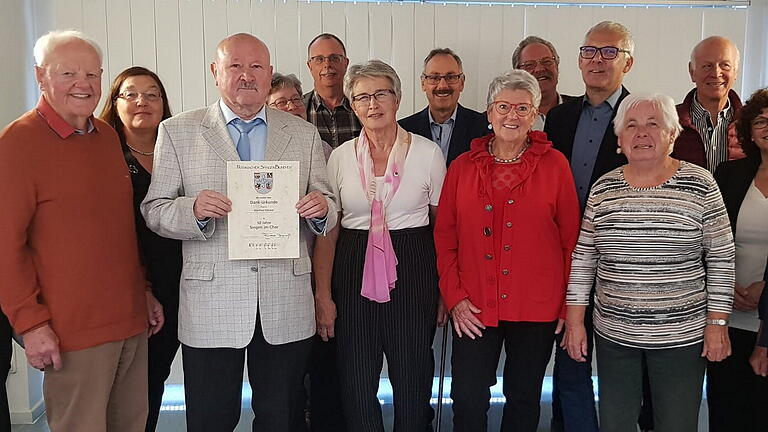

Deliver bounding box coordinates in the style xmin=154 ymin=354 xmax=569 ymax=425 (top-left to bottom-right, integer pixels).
xmin=181 ymin=317 xmax=312 ymax=432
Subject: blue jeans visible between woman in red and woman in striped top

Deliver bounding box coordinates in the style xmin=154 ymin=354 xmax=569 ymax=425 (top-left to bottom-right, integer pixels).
xmin=551 ymin=305 xmax=598 ymax=432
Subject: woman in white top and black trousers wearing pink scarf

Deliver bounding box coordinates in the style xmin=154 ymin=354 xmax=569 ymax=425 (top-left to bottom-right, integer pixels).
xmin=315 ymin=60 xmax=445 ymax=432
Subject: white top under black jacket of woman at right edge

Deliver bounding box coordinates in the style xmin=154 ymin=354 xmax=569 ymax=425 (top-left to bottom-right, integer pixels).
xmin=731 ymin=180 xmax=768 ymax=332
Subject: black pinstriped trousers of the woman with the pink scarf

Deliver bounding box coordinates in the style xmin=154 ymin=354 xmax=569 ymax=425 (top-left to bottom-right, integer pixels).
xmin=332 ymin=227 xmax=439 ymax=432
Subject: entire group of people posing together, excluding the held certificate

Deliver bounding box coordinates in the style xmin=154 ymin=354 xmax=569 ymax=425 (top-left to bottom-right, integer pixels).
xmin=0 ymin=16 xmax=768 ymax=432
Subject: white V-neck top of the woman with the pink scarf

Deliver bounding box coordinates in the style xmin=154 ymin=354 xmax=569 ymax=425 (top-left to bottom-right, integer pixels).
xmin=328 ymin=134 xmax=446 ymax=230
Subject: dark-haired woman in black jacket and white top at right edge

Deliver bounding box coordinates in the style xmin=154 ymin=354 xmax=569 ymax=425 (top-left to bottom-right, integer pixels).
xmin=707 ymin=89 xmax=768 ymax=432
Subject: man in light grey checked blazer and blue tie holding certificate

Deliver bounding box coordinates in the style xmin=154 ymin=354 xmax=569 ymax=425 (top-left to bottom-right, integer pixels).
xmin=141 ymin=33 xmax=337 ymax=432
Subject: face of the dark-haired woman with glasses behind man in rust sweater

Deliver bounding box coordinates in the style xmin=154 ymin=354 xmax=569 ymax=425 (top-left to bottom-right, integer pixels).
xmin=115 ymin=75 xmax=163 ymax=130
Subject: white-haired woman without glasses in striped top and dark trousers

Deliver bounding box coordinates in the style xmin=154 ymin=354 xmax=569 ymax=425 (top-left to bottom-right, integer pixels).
xmin=563 ymin=94 xmax=734 ymax=432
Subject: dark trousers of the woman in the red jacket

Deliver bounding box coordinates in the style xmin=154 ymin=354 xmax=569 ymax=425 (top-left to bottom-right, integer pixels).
xmin=451 ymin=321 xmax=557 ymax=432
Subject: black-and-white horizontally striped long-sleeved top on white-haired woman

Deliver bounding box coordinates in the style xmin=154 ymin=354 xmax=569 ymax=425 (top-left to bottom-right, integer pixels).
xmin=566 ymin=162 xmax=734 ymax=349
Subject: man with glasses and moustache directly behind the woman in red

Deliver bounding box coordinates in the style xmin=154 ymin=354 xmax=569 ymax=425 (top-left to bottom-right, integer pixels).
xmin=512 ymin=36 xmax=577 ymax=130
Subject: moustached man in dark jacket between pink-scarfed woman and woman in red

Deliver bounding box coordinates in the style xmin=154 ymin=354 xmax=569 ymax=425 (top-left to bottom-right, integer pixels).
xmin=399 ymin=48 xmax=490 ymax=164
